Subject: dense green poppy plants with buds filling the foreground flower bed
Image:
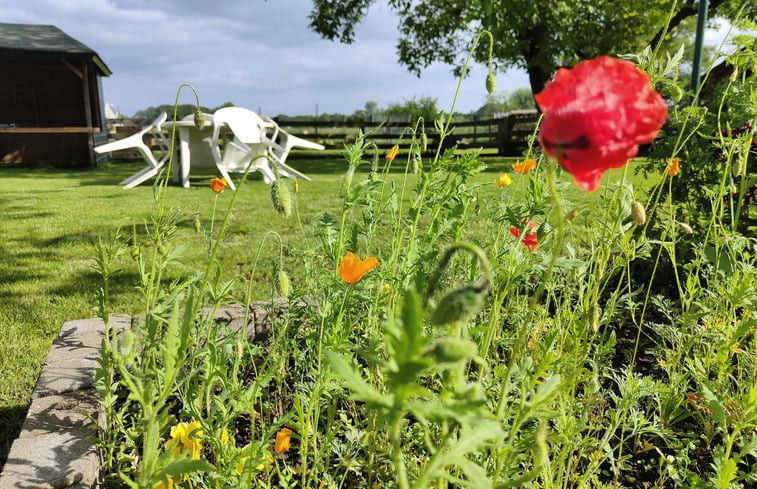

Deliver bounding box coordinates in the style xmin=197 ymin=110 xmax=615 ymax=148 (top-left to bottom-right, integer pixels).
xmin=91 ymin=32 xmax=757 ymax=489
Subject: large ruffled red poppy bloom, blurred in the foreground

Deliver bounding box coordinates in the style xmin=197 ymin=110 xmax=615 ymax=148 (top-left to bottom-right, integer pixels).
xmin=534 ymin=56 xmax=667 ymax=190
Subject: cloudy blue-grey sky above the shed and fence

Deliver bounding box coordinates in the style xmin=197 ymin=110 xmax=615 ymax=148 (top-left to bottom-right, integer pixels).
xmin=0 ymin=0 xmax=740 ymax=116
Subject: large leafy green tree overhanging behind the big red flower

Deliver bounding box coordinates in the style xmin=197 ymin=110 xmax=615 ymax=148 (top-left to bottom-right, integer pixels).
xmin=309 ymin=0 xmax=757 ymax=97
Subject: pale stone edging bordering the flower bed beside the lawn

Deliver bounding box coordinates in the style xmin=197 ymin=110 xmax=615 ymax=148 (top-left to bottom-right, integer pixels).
xmin=0 ymin=298 xmax=298 ymax=489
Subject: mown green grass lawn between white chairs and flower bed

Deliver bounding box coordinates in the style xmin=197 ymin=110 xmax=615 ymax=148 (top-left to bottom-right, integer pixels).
xmin=0 ymin=153 xmax=652 ymax=466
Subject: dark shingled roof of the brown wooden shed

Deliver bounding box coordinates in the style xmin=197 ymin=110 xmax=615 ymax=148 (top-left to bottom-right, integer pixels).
xmin=0 ymin=23 xmax=112 ymax=76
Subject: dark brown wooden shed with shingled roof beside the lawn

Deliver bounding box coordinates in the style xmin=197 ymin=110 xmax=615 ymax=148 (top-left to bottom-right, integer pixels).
xmin=0 ymin=23 xmax=111 ymax=165
